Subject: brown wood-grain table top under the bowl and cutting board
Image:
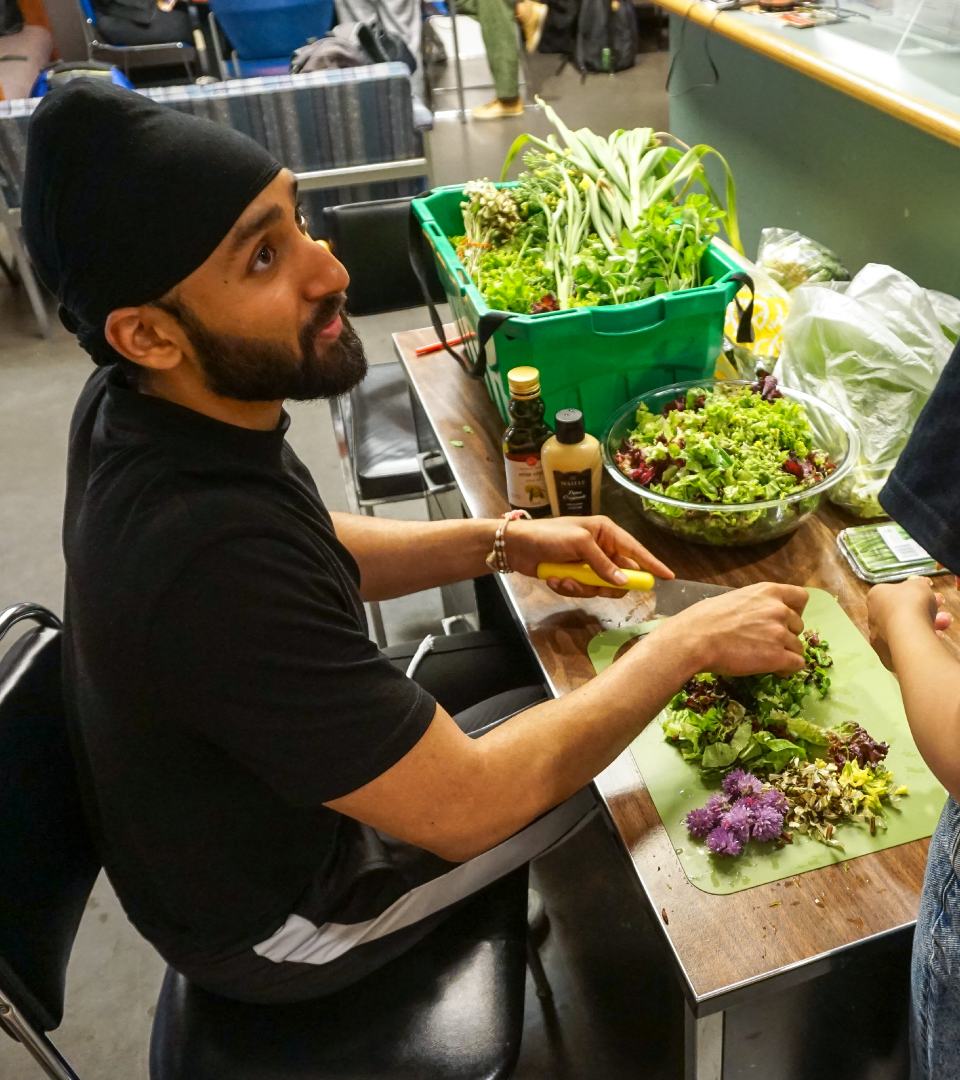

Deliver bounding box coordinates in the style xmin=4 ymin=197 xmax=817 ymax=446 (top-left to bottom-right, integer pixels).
xmin=394 ymin=327 xmax=960 ymax=1014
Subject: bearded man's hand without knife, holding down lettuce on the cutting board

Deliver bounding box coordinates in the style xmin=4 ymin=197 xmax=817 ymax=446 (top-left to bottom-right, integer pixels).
xmin=651 ymin=581 xmax=809 ymax=676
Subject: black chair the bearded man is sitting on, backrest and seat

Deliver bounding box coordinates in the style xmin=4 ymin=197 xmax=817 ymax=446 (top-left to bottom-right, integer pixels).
xmin=0 ymin=604 xmax=539 ymax=1080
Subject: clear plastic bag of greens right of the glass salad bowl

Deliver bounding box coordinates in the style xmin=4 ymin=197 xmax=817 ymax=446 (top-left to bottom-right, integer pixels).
xmin=775 ymin=262 xmax=960 ymax=517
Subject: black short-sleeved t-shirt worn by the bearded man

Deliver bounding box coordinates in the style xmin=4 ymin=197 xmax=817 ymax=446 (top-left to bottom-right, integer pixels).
xmin=64 ymin=369 xmax=435 ymax=963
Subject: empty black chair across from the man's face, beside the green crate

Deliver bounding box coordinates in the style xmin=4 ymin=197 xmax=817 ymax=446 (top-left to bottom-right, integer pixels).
xmin=323 ymin=199 xmax=454 ymax=648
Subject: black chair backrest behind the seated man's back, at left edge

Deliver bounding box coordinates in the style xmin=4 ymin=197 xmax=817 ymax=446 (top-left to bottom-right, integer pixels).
xmin=0 ymin=613 xmax=100 ymax=1031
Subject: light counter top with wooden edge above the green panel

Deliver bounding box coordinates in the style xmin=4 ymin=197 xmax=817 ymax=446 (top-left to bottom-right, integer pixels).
xmin=654 ymin=0 xmax=960 ymax=153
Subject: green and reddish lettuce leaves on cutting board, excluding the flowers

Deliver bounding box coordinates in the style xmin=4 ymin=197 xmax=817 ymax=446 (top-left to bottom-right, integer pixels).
xmin=663 ymin=631 xmax=833 ymax=772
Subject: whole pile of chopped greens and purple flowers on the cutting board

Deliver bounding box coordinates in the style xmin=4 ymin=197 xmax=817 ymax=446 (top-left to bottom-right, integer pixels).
xmin=663 ymin=631 xmax=907 ymax=855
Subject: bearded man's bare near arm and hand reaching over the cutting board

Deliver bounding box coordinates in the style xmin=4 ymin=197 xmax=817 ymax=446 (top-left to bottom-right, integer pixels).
xmin=327 ymin=583 xmax=807 ymax=862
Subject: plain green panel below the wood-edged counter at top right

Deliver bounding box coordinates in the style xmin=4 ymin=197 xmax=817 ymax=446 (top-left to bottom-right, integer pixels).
xmin=671 ymin=17 xmax=960 ymax=296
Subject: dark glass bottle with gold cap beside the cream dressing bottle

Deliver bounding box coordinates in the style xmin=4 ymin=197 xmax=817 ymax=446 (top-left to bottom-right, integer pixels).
xmin=503 ymin=367 xmax=553 ymax=517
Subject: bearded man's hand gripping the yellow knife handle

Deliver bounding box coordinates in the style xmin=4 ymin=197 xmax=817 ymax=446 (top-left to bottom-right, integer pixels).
xmin=505 ymin=514 xmax=674 ymax=597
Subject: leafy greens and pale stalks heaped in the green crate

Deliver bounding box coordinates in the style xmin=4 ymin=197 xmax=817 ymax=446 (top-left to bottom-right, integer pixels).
xmin=451 ymin=98 xmax=740 ymax=314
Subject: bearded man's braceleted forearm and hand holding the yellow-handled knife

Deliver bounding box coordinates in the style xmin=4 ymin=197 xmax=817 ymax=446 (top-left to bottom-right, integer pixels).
xmin=330 ymin=513 xmax=673 ymax=600
